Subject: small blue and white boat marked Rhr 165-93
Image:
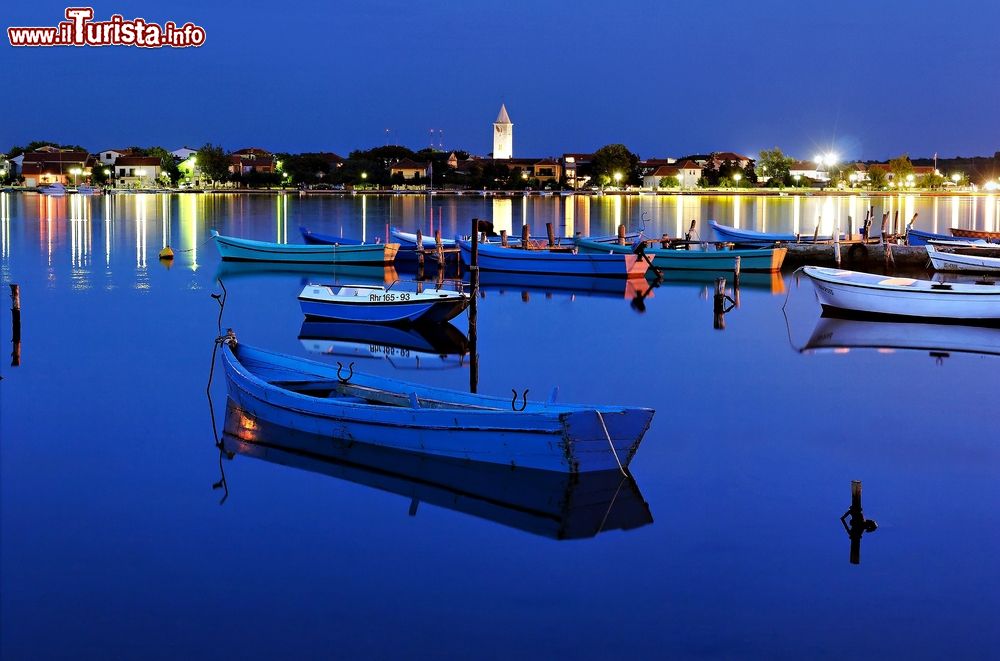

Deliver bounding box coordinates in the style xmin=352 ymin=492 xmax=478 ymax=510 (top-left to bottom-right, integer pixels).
xmin=299 ymin=282 xmax=469 ymax=324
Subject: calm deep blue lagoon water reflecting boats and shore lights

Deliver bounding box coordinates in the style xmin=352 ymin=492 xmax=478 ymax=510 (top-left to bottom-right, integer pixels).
xmin=0 ymin=193 xmax=1000 ymax=659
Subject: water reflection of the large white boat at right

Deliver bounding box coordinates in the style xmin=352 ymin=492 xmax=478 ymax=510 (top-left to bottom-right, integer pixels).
xmin=799 ymin=312 xmax=1000 ymax=361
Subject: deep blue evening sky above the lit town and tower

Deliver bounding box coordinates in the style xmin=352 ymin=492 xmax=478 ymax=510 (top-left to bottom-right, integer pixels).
xmin=0 ymin=0 xmax=1000 ymax=158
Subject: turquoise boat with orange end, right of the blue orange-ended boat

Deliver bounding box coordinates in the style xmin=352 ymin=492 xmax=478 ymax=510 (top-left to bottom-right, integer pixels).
xmin=576 ymin=238 xmax=787 ymax=274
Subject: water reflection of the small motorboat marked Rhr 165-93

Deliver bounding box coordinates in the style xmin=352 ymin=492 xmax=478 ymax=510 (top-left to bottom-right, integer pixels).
xmin=299 ymin=320 xmax=469 ymax=369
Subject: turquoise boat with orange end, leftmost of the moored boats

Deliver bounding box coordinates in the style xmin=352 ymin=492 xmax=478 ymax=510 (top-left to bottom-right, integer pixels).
xmin=212 ymin=230 xmax=399 ymax=264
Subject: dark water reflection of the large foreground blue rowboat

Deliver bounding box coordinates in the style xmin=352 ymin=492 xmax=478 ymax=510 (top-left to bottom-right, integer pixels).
xmin=220 ymin=400 xmax=653 ymax=539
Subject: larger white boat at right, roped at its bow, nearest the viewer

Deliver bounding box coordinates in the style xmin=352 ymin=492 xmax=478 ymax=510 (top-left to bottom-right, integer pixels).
xmin=803 ymin=266 xmax=1000 ymax=324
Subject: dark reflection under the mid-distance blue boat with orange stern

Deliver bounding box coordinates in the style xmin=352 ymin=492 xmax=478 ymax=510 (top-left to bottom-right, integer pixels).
xmin=479 ymin=271 xmax=655 ymax=311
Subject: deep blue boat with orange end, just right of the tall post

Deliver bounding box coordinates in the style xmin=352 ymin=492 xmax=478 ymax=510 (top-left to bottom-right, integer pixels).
xmin=458 ymin=239 xmax=649 ymax=278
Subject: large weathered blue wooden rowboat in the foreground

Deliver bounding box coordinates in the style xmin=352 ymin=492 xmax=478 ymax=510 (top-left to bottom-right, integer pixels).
xmin=221 ymin=336 xmax=653 ymax=473
